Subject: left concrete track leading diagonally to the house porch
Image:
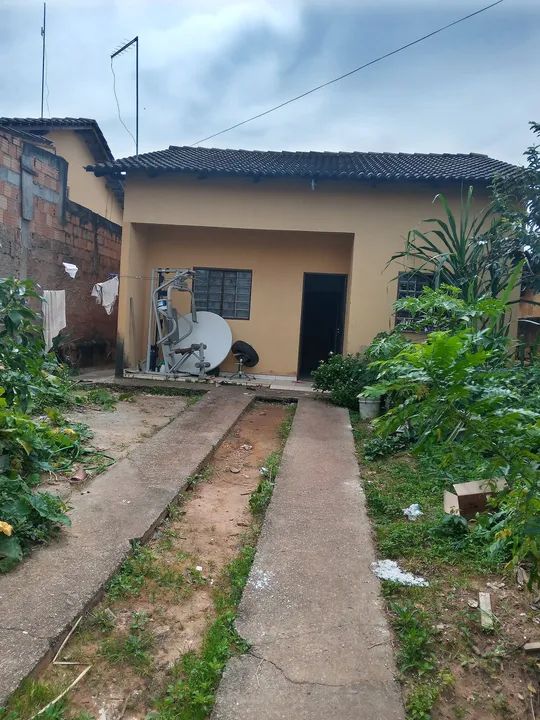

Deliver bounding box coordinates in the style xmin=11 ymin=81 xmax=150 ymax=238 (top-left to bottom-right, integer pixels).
xmin=0 ymin=388 xmax=253 ymax=706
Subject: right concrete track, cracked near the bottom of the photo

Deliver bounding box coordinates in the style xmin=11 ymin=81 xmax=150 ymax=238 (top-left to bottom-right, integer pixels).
xmin=212 ymin=399 xmax=404 ymax=720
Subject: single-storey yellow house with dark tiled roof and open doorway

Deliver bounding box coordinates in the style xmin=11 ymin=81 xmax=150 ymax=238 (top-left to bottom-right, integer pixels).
xmin=88 ymin=146 xmax=514 ymax=377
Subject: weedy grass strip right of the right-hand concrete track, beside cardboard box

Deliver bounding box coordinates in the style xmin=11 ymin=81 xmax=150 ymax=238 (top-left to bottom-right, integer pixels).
xmin=351 ymin=413 xmax=524 ymax=720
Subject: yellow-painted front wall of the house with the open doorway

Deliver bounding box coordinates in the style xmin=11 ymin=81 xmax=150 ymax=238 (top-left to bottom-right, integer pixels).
xmin=119 ymin=176 xmax=494 ymax=375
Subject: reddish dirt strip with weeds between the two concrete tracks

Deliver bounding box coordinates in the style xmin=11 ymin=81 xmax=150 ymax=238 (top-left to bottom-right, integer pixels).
xmin=20 ymin=397 xmax=286 ymax=720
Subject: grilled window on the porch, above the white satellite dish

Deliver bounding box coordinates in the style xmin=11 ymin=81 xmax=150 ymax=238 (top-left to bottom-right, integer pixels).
xmin=193 ymin=268 xmax=252 ymax=320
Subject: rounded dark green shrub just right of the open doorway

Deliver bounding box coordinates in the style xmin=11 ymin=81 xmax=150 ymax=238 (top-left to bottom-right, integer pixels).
xmin=313 ymin=354 xmax=374 ymax=409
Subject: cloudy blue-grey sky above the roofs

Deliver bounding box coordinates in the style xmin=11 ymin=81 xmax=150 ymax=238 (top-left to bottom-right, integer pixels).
xmin=0 ymin=0 xmax=540 ymax=163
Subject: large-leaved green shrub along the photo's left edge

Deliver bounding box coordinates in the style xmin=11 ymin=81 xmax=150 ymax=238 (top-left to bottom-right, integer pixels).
xmin=0 ymin=278 xmax=82 ymax=572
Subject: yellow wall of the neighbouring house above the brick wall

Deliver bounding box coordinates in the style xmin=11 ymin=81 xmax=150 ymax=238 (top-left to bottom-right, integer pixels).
xmin=47 ymin=130 xmax=122 ymax=225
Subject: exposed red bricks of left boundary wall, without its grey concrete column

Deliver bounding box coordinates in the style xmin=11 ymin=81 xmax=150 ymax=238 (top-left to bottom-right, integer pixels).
xmin=0 ymin=131 xmax=121 ymax=360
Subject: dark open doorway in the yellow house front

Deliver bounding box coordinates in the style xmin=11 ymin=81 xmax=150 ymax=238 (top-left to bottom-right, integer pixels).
xmin=298 ymin=273 xmax=347 ymax=380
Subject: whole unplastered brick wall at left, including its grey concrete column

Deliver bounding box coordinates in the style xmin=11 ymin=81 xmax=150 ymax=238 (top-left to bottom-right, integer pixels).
xmin=0 ymin=131 xmax=121 ymax=362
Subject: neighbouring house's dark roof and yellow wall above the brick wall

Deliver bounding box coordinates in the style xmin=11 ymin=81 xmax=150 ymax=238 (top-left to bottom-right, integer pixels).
xmin=0 ymin=118 xmax=123 ymax=225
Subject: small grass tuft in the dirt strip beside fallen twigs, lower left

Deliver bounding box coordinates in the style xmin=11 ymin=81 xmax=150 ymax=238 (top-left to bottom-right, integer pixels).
xmin=100 ymin=612 xmax=154 ymax=674
